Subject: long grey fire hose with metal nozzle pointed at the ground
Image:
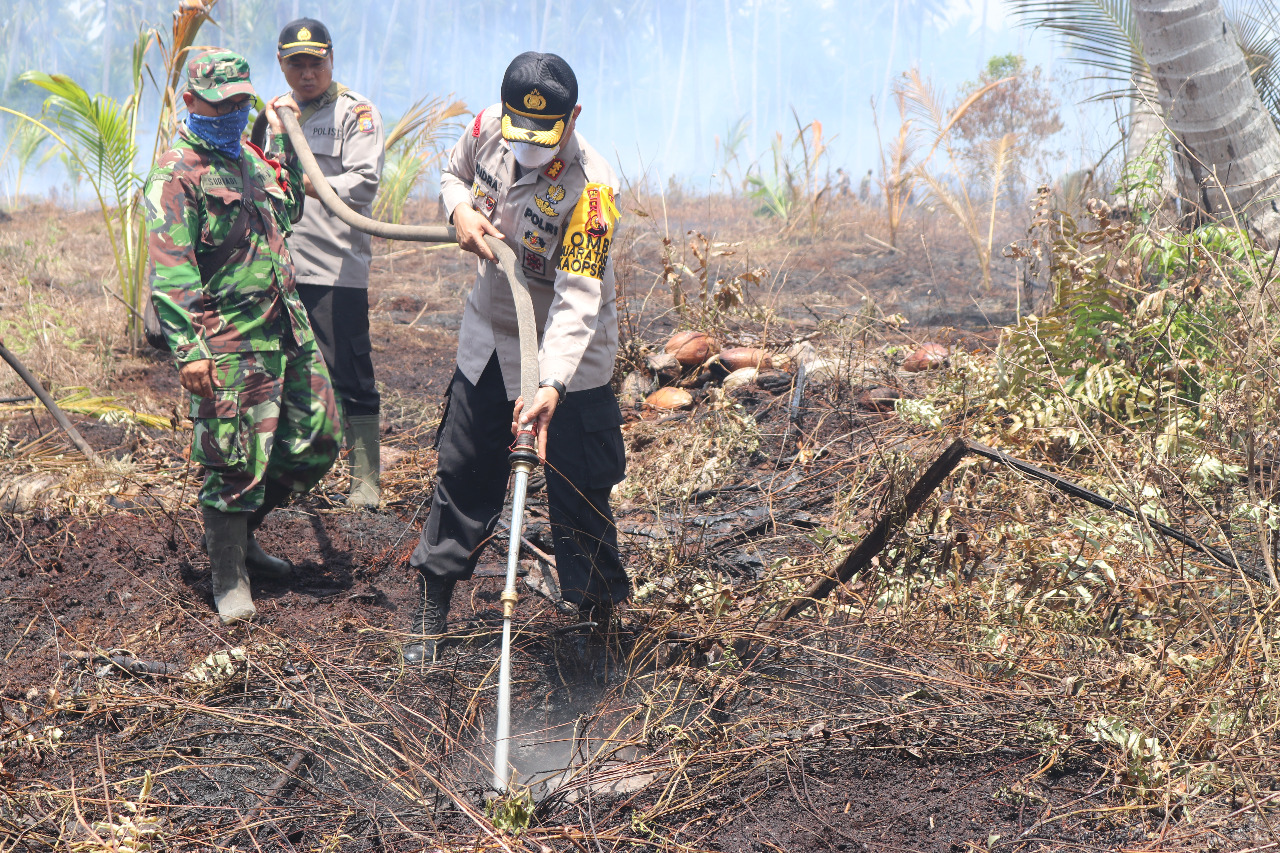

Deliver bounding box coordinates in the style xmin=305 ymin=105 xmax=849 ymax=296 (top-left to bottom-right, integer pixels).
xmin=277 ymin=109 xmax=539 ymax=793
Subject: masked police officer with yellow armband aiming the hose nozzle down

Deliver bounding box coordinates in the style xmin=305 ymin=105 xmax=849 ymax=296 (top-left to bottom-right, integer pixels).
xmin=403 ymin=53 xmax=631 ymax=662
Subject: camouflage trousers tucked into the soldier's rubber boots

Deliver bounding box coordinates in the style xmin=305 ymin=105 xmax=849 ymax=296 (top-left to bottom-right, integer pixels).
xmin=191 ymin=343 xmax=342 ymax=512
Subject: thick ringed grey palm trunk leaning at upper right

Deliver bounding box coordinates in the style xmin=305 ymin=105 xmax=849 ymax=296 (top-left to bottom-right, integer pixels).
xmin=1133 ymin=0 xmax=1280 ymax=245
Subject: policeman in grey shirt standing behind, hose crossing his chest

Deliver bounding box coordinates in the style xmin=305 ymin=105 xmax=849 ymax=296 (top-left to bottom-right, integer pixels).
xmin=276 ymin=18 xmax=384 ymax=507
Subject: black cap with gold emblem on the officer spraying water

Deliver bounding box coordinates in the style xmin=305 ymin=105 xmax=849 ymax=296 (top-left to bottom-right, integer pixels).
xmin=502 ymin=50 xmax=577 ymax=149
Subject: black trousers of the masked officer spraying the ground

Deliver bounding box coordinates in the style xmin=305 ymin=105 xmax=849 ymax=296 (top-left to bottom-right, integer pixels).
xmin=410 ymin=355 xmax=631 ymax=605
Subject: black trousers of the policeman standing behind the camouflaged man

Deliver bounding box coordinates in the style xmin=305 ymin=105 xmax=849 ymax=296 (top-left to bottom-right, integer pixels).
xmin=297 ymin=284 xmax=381 ymax=418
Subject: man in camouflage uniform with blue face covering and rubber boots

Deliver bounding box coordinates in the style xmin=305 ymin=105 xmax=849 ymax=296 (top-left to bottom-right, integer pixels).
xmin=145 ymin=49 xmax=340 ymax=624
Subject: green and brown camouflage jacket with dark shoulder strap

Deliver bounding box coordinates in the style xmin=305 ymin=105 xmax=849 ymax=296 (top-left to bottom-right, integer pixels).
xmin=143 ymin=121 xmax=314 ymax=362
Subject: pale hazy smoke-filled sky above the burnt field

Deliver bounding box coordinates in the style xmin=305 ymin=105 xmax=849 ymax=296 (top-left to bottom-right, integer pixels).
xmin=0 ymin=0 xmax=1114 ymax=195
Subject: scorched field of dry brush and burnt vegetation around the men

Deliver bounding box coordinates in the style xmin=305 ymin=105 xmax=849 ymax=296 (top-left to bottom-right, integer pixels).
xmin=0 ymin=3 xmax=1280 ymax=853
